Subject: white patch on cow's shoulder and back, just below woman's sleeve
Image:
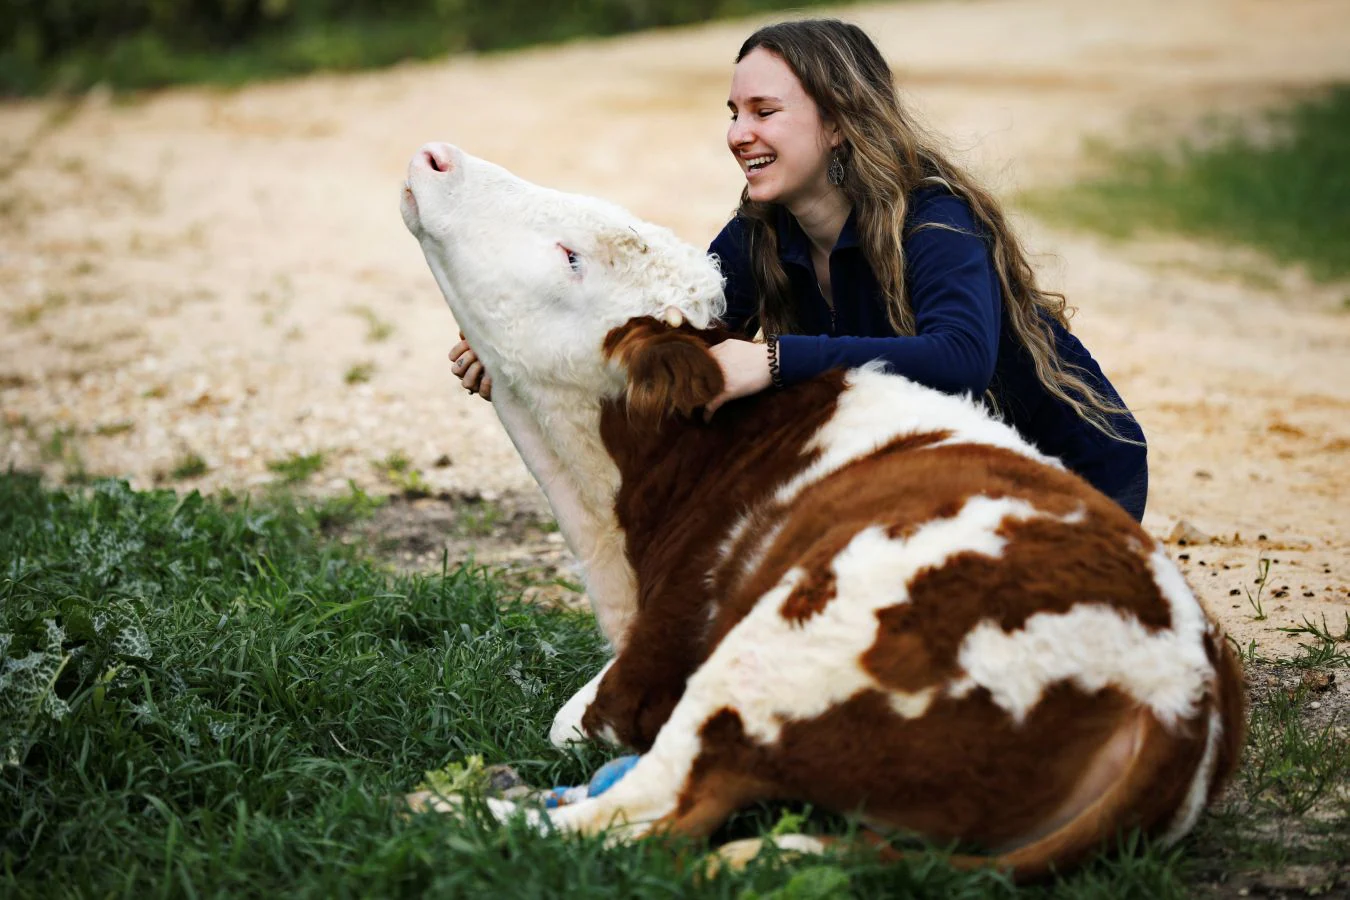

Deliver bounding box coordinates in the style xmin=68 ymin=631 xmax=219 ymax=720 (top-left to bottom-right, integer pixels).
xmin=775 ymin=363 xmax=1064 ymax=505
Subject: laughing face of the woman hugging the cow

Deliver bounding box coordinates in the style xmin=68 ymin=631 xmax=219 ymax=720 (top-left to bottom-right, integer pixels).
xmin=726 ymin=47 xmax=841 ymax=209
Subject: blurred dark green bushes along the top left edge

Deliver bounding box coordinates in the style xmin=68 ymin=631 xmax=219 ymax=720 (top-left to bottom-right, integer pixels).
xmin=0 ymin=0 xmax=842 ymax=94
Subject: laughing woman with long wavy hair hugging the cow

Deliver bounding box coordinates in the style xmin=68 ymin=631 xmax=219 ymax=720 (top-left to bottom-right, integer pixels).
xmin=451 ymin=19 xmax=1148 ymax=518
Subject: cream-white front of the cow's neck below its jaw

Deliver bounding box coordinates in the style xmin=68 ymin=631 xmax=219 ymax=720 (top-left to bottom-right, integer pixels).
xmin=493 ymin=386 xmax=637 ymax=650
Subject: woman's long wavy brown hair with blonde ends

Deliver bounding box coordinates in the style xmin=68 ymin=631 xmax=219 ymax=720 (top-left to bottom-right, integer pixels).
xmin=736 ymin=19 xmax=1134 ymax=443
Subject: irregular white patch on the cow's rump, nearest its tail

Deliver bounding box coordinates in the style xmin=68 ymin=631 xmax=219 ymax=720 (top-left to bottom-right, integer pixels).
xmin=949 ymin=548 xmax=1214 ymax=727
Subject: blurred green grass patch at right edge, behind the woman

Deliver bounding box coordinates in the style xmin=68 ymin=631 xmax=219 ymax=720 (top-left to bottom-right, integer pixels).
xmin=1021 ymin=85 xmax=1350 ymax=281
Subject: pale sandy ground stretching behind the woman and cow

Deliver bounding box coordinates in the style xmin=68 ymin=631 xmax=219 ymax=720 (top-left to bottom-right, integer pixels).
xmin=0 ymin=0 xmax=1350 ymax=653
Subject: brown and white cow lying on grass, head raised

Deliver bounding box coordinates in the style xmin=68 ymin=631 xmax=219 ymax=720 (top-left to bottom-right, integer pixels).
xmin=402 ymin=144 xmax=1243 ymax=877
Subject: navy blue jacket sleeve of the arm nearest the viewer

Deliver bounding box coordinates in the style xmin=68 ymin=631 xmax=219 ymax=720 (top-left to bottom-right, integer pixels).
xmin=779 ymin=194 xmax=1003 ymax=394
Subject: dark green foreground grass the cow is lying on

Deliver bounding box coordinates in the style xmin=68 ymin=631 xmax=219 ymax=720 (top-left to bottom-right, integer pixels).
xmin=0 ymin=474 xmax=1345 ymax=900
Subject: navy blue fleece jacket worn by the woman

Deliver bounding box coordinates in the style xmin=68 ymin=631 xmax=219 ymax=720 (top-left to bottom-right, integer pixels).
xmin=709 ymin=188 xmax=1146 ymax=497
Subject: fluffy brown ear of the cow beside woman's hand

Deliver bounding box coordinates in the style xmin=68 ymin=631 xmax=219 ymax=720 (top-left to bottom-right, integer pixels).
xmin=605 ymin=316 xmax=722 ymax=417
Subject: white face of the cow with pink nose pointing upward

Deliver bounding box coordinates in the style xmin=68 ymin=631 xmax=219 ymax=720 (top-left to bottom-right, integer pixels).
xmin=402 ymin=144 xmax=725 ymax=395
